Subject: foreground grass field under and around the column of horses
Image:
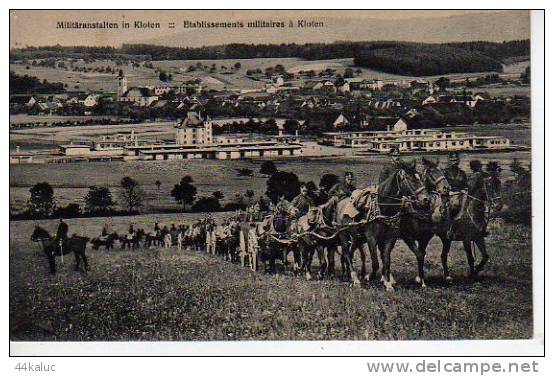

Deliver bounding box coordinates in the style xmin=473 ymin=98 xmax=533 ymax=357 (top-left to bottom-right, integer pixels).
xmin=9 ymin=214 xmax=533 ymax=341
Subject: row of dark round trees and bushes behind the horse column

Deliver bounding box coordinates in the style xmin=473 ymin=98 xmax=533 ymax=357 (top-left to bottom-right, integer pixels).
xmin=10 ymin=159 xmax=532 ymax=225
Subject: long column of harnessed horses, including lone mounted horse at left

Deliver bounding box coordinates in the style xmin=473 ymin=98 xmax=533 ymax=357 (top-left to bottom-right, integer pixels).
xmin=31 ymin=158 xmax=502 ymax=290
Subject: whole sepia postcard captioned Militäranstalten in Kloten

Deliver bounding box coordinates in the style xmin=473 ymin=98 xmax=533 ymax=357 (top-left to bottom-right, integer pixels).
xmin=8 ymin=9 xmax=544 ymax=356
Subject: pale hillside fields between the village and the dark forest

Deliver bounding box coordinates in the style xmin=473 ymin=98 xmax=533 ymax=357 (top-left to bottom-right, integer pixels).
xmin=10 ymin=58 xmax=529 ymax=92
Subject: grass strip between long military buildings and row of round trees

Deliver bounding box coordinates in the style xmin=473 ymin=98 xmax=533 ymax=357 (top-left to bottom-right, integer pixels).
xmin=10 ymin=149 xmax=531 ymax=212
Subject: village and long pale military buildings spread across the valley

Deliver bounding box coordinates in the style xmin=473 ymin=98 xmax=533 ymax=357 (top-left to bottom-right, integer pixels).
xmin=10 ymin=63 xmax=529 ymax=163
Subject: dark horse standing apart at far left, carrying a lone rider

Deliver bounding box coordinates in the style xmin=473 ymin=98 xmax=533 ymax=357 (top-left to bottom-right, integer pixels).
xmin=31 ymin=225 xmax=89 ymax=274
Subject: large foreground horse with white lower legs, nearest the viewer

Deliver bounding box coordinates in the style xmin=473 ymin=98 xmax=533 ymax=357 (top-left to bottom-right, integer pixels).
xmin=343 ymin=161 xmax=429 ymax=290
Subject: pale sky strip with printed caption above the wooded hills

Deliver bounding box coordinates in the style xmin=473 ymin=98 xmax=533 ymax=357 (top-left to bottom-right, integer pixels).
xmin=10 ymin=10 xmax=529 ymax=48
